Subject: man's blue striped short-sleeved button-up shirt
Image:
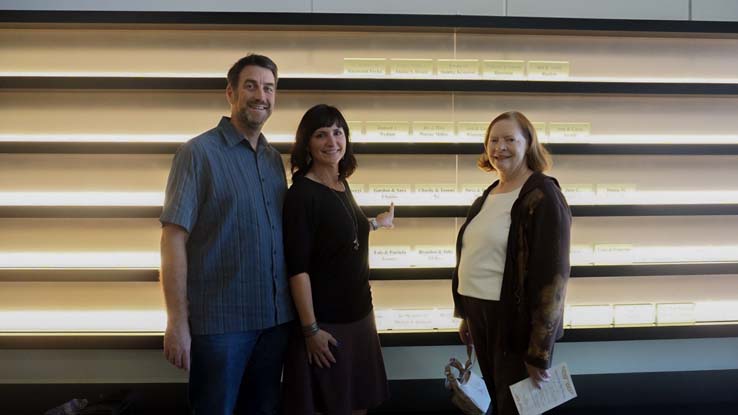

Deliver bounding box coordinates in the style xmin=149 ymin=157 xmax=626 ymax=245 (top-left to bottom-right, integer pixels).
xmin=159 ymin=117 xmax=294 ymax=334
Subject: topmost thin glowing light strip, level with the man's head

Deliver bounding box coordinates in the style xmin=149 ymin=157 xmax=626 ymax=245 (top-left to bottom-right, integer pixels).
xmin=0 ymin=71 xmax=738 ymax=84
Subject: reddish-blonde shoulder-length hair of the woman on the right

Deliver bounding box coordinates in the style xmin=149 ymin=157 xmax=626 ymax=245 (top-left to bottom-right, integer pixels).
xmin=477 ymin=111 xmax=553 ymax=173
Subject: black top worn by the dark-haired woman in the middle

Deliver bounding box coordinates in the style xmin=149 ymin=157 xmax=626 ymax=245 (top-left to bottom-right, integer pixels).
xmin=284 ymin=177 xmax=372 ymax=323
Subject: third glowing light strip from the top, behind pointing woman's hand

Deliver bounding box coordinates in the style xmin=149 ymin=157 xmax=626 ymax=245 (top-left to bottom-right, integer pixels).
xmin=0 ymin=192 xmax=738 ymax=207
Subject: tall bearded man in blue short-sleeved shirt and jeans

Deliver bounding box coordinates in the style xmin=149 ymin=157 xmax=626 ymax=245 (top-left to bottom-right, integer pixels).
xmin=159 ymin=54 xmax=294 ymax=415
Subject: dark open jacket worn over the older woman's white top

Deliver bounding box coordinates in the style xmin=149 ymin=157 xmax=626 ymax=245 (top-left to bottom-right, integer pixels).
xmin=451 ymin=173 xmax=571 ymax=369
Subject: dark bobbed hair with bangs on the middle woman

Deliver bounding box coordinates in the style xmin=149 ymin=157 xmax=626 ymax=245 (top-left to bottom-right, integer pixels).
xmin=290 ymin=104 xmax=356 ymax=179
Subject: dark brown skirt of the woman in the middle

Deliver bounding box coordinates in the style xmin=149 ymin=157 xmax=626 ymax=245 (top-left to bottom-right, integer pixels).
xmin=283 ymin=312 xmax=389 ymax=415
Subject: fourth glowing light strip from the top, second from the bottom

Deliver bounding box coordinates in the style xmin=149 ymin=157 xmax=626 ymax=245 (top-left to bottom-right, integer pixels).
xmin=0 ymin=245 xmax=738 ymax=269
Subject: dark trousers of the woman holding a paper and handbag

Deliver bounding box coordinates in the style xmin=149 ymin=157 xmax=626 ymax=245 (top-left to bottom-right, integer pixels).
xmin=462 ymin=296 xmax=528 ymax=415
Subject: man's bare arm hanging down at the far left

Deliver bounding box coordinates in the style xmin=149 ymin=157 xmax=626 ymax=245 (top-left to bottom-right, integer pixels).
xmin=161 ymin=224 xmax=191 ymax=370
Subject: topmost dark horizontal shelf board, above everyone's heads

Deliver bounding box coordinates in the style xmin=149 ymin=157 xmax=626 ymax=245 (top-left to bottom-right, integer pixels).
xmin=0 ymin=10 xmax=738 ymax=36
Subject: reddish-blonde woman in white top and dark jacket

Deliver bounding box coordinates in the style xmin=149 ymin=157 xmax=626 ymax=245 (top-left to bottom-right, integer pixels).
xmin=452 ymin=112 xmax=571 ymax=415
